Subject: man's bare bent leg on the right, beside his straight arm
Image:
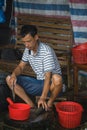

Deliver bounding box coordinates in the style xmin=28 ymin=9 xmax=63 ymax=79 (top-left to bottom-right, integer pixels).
xmin=47 ymin=74 xmax=62 ymax=107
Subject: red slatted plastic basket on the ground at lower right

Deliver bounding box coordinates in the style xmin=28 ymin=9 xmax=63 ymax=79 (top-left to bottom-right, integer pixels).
xmin=56 ymin=101 xmax=83 ymax=128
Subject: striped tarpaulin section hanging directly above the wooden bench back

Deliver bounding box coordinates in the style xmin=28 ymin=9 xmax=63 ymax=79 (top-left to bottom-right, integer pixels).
xmin=14 ymin=0 xmax=69 ymax=17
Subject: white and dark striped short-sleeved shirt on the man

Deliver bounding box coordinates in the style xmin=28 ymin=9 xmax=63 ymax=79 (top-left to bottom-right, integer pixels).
xmin=22 ymin=42 xmax=61 ymax=80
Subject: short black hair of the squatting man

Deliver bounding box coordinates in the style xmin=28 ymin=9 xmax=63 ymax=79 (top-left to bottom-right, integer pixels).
xmin=20 ymin=25 xmax=37 ymax=37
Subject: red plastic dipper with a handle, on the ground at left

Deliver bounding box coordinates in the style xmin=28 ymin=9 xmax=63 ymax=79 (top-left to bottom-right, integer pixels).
xmin=6 ymin=97 xmax=30 ymax=121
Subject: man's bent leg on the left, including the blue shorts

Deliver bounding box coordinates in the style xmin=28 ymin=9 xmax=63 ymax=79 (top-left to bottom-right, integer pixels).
xmin=6 ymin=76 xmax=43 ymax=107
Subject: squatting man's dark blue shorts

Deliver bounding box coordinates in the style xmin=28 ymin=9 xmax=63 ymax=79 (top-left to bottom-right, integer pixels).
xmin=17 ymin=76 xmax=44 ymax=96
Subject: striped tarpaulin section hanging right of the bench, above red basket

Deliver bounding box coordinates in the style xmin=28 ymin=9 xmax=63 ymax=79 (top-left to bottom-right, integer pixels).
xmin=69 ymin=0 xmax=87 ymax=45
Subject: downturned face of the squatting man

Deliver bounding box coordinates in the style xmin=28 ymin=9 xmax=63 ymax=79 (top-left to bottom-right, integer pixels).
xmin=22 ymin=34 xmax=38 ymax=50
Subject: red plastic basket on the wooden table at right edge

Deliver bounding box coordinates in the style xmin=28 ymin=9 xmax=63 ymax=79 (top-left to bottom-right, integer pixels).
xmin=72 ymin=42 xmax=87 ymax=64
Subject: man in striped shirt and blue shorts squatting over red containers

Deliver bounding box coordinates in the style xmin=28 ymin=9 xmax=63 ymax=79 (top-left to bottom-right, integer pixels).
xmin=6 ymin=25 xmax=62 ymax=110
